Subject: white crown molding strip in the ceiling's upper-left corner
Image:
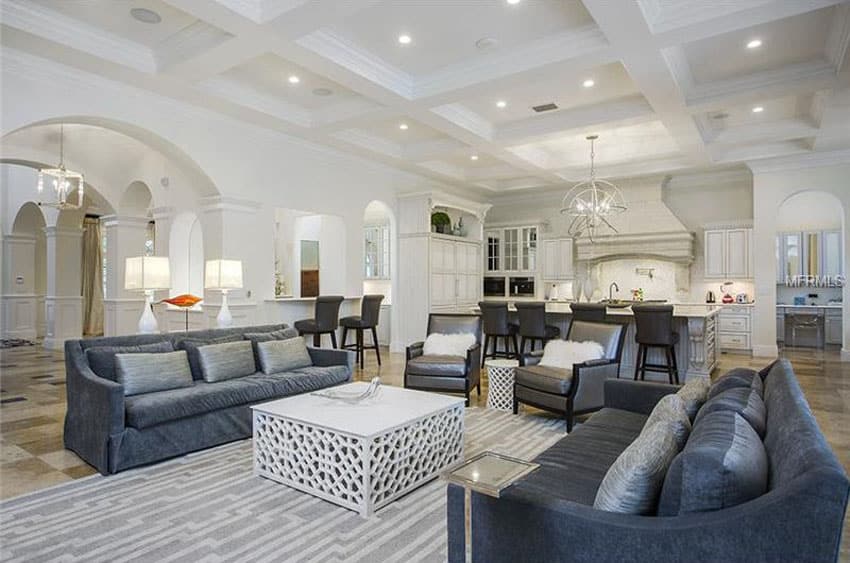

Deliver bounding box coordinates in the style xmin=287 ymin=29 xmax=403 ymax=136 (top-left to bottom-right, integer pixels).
xmin=0 ymin=0 xmax=156 ymax=73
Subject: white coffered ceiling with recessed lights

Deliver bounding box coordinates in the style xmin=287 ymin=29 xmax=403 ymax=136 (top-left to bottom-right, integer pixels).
xmin=0 ymin=0 xmax=850 ymax=195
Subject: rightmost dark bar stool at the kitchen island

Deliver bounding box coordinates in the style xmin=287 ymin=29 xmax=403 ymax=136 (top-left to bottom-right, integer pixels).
xmin=632 ymin=305 xmax=679 ymax=385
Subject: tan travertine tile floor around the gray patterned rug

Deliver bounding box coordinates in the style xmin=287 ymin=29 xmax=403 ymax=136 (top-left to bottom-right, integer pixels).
xmin=0 ymin=346 xmax=850 ymax=561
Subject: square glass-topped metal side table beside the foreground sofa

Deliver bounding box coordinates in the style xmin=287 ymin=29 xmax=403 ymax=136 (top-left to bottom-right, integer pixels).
xmin=444 ymin=452 xmax=540 ymax=563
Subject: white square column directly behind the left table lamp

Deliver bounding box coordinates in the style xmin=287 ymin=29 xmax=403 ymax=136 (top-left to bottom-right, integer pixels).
xmin=101 ymin=215 xmax=148 ymax=336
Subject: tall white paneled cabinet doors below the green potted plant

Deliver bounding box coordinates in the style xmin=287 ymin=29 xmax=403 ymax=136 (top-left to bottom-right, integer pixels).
xmin=431 ymin=235 xmax=481 ymax=310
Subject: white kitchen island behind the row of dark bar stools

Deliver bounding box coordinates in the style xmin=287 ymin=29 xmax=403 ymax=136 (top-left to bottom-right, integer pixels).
xmin=473 ymin=301 xmax=720 ymax=383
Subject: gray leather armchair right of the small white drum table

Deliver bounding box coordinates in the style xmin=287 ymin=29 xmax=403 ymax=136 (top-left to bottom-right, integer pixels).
xmin=514 ymin=321 xmax=626 ymax=432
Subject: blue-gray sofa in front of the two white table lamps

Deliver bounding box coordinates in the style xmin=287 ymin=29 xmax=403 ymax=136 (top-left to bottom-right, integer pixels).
xmin=64 ymin=325 xmax=354 ymax=474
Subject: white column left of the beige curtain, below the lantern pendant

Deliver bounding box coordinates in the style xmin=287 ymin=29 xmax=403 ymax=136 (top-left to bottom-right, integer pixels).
xmin=44 ymin=225 xmax=83 ymax=350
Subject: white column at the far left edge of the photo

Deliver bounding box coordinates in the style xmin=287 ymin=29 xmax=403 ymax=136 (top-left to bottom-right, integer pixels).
xmin=0 ymin=234 xmax=39 ymax=340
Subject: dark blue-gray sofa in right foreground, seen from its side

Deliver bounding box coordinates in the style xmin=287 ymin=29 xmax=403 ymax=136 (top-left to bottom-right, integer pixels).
xmin=447 ymin=360 xmax=850 ymax=563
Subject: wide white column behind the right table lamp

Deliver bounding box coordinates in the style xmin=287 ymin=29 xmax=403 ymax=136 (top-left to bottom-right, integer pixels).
xmin=200 ymin=196 xmax=266 ymax=327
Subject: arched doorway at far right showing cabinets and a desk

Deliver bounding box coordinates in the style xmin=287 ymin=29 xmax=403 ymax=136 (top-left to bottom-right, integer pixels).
xmin=776 ymin=194 xmax=846 ymax=349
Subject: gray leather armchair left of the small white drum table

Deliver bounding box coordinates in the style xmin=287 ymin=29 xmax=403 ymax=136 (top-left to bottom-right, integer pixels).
xmin=404 ymin=313 xmax=481 ymax=406
